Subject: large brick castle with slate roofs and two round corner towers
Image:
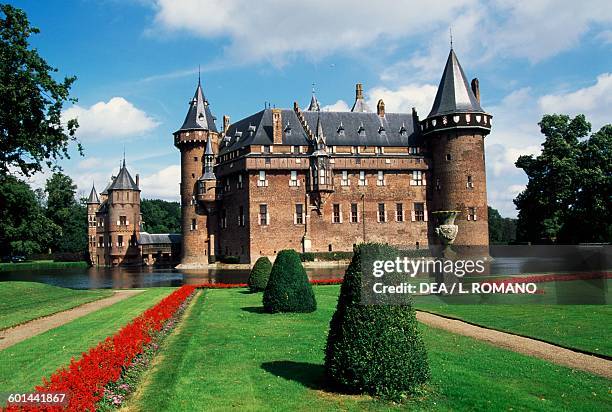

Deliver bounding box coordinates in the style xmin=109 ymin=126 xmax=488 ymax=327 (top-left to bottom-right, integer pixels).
xmin=175 ymin=49 xmax=491 ymax=267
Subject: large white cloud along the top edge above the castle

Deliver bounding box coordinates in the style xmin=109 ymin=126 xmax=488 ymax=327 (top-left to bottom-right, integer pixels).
xmin=149 ymin=0 xmax=477 ymax=63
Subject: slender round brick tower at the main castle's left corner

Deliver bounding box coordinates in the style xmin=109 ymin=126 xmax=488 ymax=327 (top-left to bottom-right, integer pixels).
xmin=174 ymin=80 xmax=219 ymax=265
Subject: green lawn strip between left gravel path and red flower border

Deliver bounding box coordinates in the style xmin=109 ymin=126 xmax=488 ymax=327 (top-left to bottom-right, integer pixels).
xmin=0 ymin=288 xmax=174 ymax=393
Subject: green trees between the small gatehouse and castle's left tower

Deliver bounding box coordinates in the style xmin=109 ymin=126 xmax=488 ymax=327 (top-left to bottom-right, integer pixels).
xmin=140 ymin=199 xmax=181 ymax=233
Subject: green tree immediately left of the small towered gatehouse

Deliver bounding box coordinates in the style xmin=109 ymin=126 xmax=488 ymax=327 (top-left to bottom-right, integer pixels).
xmin=45 ymin=172 xmax=87 ymax=253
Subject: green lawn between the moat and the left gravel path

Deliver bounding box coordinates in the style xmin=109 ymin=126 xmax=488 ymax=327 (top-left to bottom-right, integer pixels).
xmin=0 ymin=282 xmax=113 ymax=329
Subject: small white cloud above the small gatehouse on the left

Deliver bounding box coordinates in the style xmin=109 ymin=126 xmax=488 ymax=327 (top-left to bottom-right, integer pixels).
xmin=62 ymin=97 xmax=159 ymax=140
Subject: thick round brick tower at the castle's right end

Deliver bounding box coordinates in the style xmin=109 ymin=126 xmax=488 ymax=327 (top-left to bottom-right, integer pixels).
xmin=421 ymin=49 xmax=492 ymax=248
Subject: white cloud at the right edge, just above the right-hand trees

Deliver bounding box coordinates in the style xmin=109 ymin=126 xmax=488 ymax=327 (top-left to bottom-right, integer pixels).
xmin=538 ymin=73 xmax=612 ymax=130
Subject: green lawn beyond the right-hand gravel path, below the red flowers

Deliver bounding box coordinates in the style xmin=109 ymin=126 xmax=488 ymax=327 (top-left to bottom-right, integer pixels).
xmin=417 ymin=305 xmax=612 ymax=356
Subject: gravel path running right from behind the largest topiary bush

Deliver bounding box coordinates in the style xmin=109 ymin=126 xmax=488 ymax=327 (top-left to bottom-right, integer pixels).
xmin=417 ymin=311 xmax=612 ymax=379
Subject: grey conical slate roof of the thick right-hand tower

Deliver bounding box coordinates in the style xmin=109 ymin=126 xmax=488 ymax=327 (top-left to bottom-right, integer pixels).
xmin=427 ymin=49 xmax=484 ymax=117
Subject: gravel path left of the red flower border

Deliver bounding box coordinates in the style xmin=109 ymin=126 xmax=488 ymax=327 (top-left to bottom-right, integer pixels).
xmin=0 ymin=289 xmax=143 ymax=350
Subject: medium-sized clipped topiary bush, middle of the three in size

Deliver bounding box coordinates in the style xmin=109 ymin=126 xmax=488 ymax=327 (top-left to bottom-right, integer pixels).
xmin=263 ymin=249 xmax=317 ymax=313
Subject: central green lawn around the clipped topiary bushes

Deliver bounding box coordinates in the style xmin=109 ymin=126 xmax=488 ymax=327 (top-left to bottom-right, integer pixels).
xmin=128 ymin=286 xmax=612 ymax=411
